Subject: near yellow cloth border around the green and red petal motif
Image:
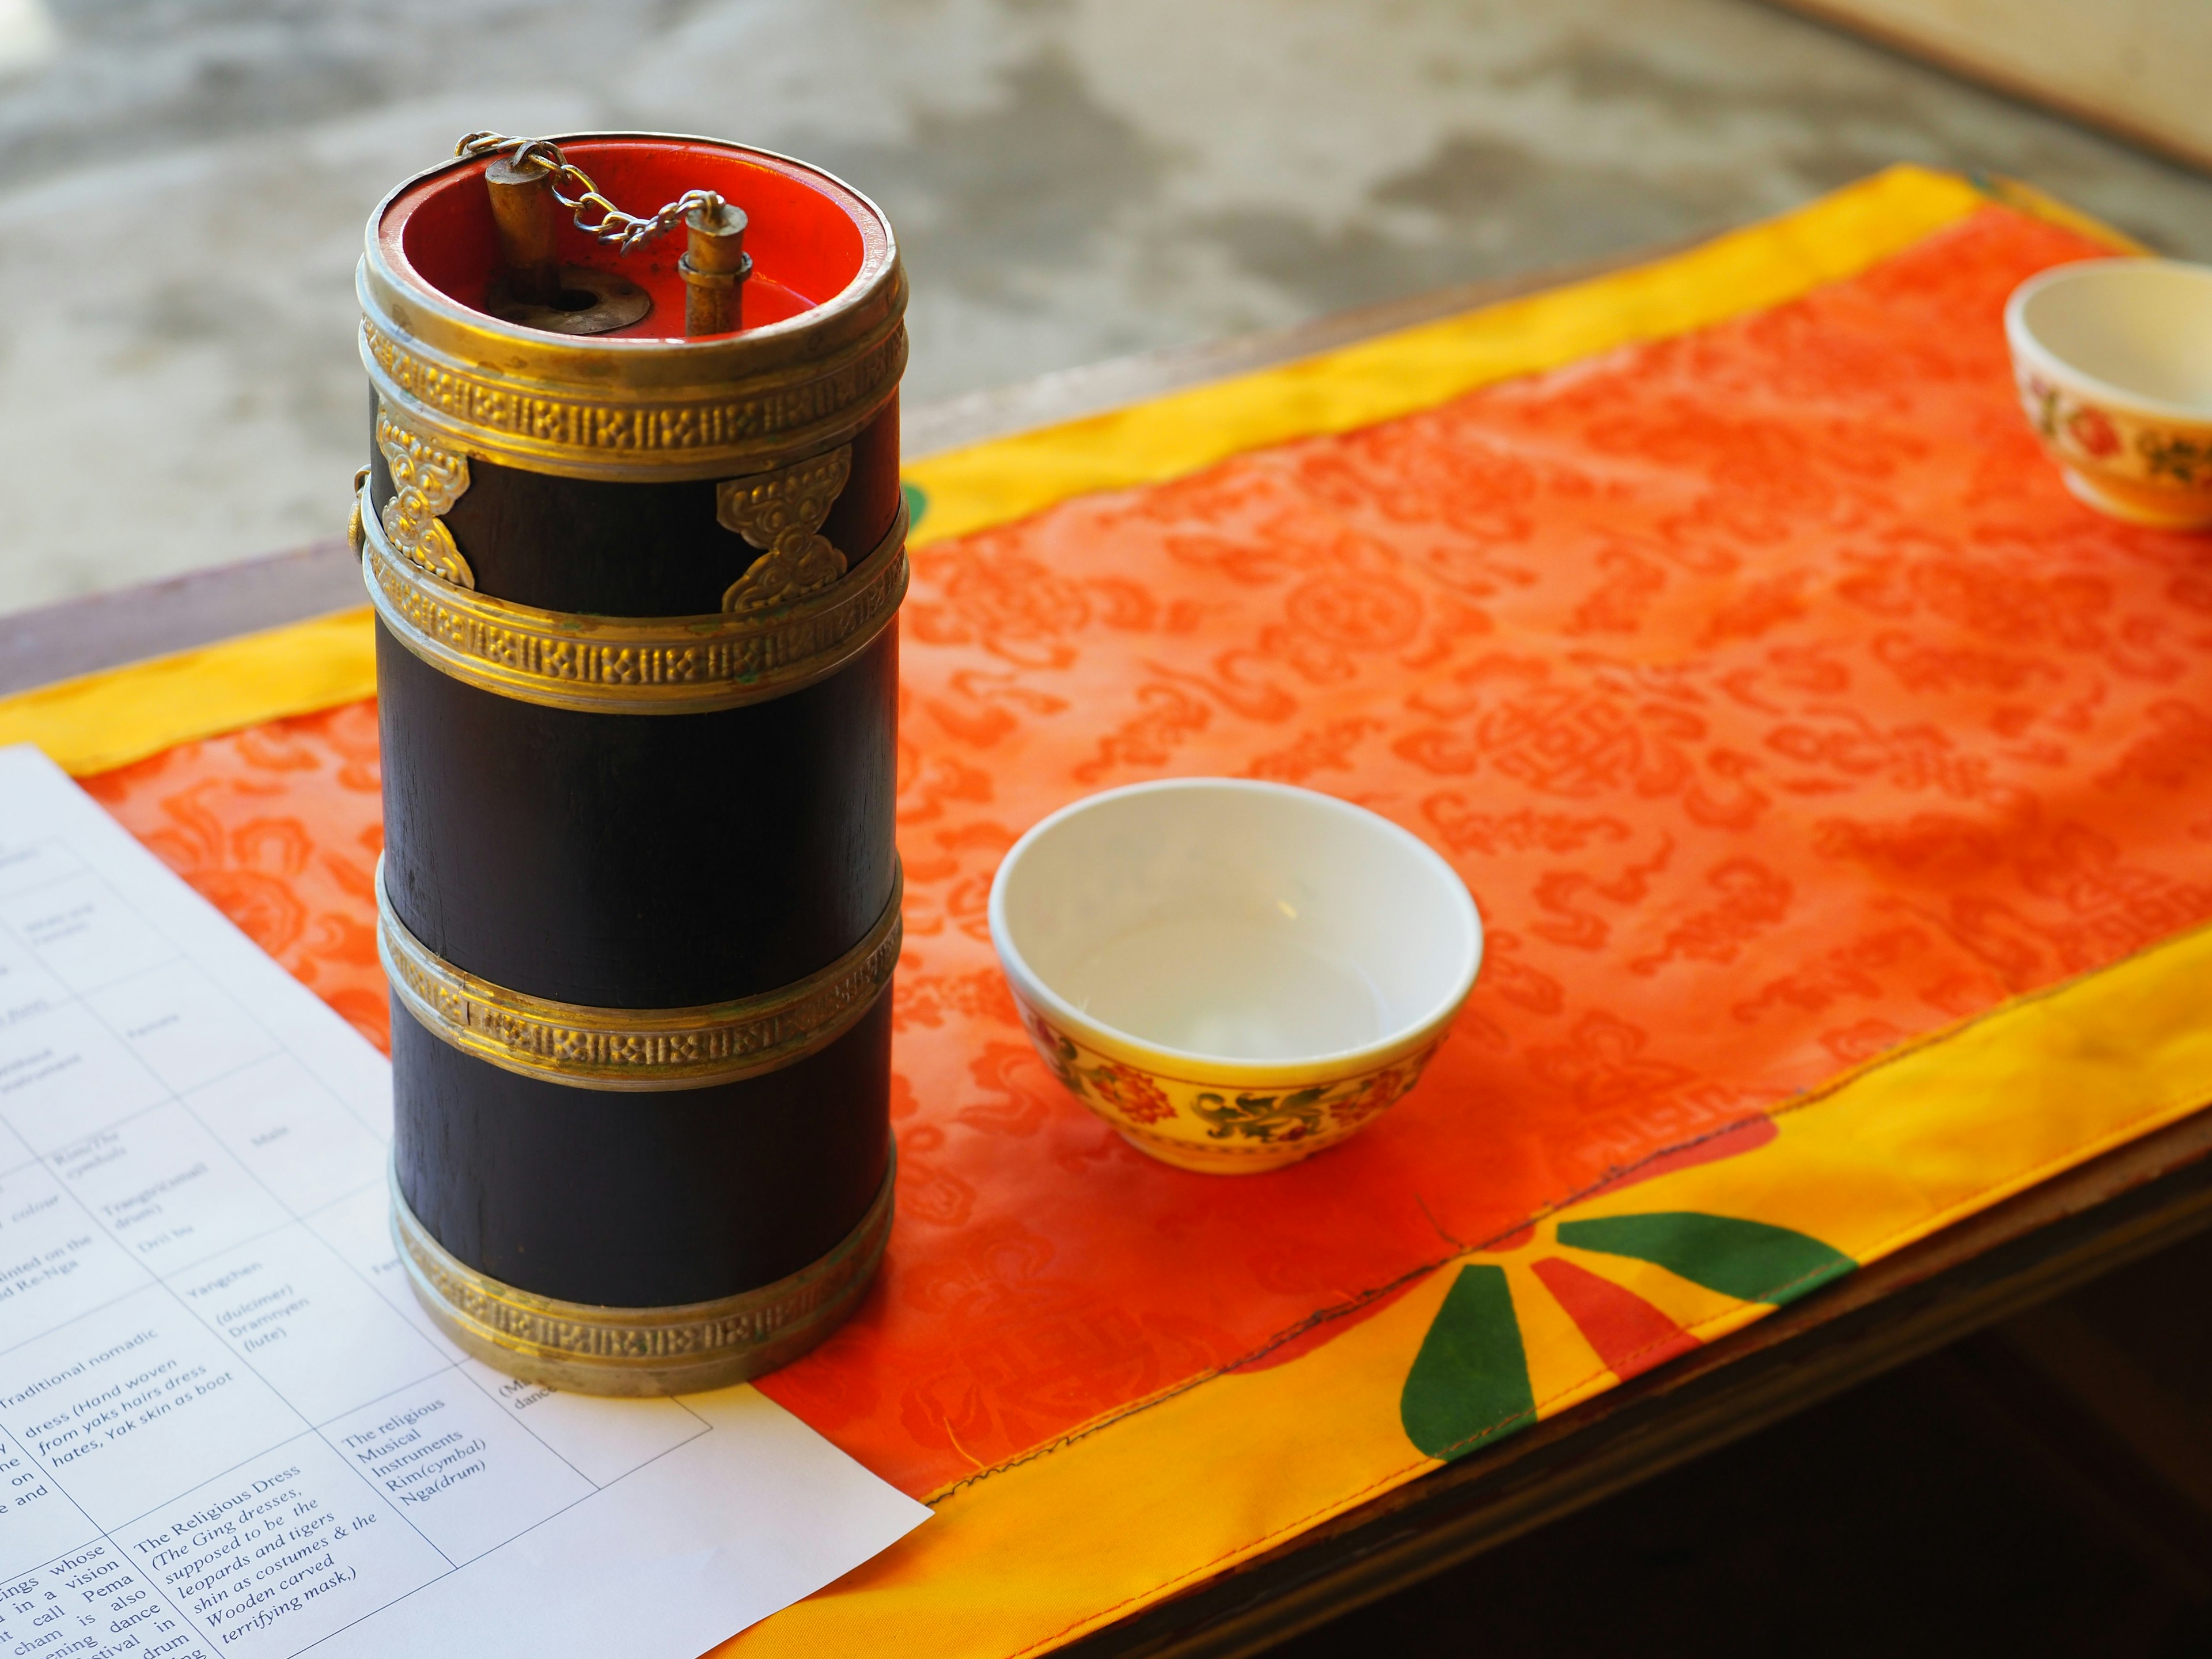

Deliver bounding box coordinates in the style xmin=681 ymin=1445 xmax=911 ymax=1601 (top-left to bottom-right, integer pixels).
xmin=738 ymin=929 xmax=2212 ymax=1659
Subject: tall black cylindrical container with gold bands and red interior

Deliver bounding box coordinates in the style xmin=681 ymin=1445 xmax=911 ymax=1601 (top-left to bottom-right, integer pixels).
xmin=356 ymin=135 xmax=907 ymax=1393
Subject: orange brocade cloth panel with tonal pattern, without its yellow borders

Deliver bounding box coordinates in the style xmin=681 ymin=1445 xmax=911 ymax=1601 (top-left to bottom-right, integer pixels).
xmin=93 ymin=208 xmax=2212 ymax=1493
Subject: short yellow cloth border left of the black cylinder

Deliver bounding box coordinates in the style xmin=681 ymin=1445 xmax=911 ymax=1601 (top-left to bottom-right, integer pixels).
xmin=0 ymin=606 xmax=376 ymax=777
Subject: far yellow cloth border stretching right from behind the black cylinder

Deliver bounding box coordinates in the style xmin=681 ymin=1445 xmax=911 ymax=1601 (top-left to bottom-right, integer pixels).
xmin=905 ymin=166 xmax=1991 ymax=546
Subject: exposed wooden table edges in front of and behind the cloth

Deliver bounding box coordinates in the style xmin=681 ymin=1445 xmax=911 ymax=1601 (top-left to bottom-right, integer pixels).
xmin=0 ymin=263 xmax=2212 ymax=1659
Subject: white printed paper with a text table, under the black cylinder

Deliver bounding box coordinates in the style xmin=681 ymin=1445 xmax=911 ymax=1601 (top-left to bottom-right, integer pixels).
xmin=0 ymin=748 xmax=929 ymax=1659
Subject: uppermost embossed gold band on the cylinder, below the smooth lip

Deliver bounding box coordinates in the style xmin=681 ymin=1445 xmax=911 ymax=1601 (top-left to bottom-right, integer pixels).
xmin=361 ymin=281 xmax=907 ymax=484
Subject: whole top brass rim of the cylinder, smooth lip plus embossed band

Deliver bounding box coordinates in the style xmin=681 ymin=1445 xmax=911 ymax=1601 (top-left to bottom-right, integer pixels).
xmin=356 ymin=132 xmax=907 ymax=482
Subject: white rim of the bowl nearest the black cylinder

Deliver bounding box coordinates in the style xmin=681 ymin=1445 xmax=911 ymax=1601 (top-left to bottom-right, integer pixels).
xmin=988 ymin=777 xmax=1484 ymax=1084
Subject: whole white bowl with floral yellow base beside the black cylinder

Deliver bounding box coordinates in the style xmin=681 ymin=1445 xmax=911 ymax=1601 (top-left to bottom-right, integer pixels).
xmin=991 ymin=779 xmax=1482 ymax=1175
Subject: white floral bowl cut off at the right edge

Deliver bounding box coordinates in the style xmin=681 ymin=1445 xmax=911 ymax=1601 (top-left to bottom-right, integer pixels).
xmin=2004 ymin=259 xmax=2212 ymax=529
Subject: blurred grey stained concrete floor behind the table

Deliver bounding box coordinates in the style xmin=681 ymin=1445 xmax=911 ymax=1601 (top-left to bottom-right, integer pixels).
xmin=0 ymin=0 xmax=2212 ymax=611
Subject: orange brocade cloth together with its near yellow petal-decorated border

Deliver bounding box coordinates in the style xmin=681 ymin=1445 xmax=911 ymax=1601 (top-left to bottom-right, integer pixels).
xmin=30 ymin=181 xmax=2212 ymax=1654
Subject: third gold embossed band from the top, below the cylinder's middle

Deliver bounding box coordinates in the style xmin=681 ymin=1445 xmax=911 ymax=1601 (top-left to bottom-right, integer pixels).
xmin=376 ymin=858 xmax=905 ymax=1093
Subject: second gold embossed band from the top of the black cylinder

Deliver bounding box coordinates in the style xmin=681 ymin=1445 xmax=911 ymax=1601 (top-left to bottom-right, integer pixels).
xmin=361 ymin=487 xmax=907 ymax=714
